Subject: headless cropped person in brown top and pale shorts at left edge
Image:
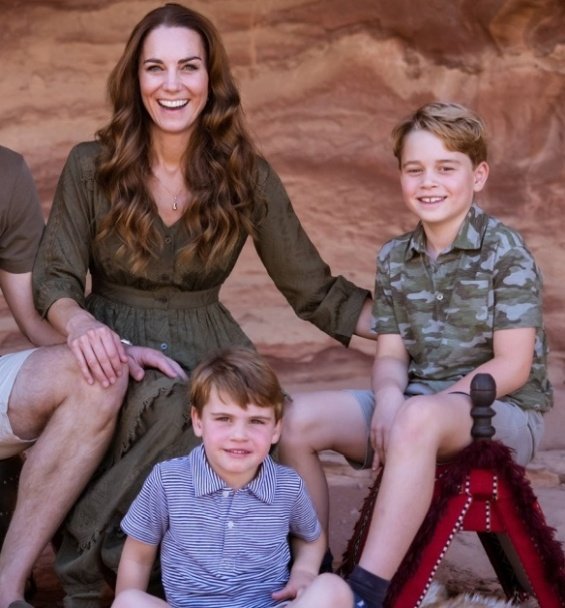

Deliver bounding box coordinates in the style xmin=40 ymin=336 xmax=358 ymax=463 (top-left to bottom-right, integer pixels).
xmin=0 ymin=146 xmax=183 ymax=608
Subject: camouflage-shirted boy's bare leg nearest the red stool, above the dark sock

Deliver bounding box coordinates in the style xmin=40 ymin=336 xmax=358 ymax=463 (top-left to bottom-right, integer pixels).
xmin=359 ymin=394 xmax=472 ymax=580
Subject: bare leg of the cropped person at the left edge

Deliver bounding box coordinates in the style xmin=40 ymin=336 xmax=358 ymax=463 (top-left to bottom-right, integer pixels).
xmin=0 ymin=346 xmax=128 ymax=608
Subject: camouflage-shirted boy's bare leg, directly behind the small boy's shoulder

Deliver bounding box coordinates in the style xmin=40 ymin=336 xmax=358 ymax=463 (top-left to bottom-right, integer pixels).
xmin=278 ymin=391 xmax=368 ymax=533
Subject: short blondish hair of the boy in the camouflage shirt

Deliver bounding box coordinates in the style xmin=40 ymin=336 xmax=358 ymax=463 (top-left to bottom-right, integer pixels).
xmin=391 ymin=101 xmax=487 ymax=167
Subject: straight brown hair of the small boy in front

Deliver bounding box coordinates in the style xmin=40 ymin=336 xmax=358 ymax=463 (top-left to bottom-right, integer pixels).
xmin=189 ymin=347 xmax=286 ymax=422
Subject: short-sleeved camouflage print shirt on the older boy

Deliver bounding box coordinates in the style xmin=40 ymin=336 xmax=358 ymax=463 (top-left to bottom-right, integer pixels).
xmin=374 ymin=205 xmax=552 ymax=412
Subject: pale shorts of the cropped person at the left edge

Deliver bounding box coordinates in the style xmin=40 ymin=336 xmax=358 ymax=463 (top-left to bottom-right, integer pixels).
xmin=0 ymin=348 xmax=37 ymax=460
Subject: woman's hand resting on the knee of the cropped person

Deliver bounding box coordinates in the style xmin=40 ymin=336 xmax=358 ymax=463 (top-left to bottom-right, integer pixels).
xmin=67 ymin=311 xmax=128 ymax=387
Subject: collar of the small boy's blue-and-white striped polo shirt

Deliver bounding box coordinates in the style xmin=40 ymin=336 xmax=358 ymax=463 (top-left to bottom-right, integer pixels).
xmin=189 ymin=444 xmax=277 ymax=504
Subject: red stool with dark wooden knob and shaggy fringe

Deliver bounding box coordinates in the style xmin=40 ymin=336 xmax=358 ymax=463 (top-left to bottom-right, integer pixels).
xmin=340 ymin=374 xmax=565 ymax=608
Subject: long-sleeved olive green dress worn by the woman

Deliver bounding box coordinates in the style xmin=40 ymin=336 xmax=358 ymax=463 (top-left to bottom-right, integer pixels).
xmin=33 ymin=142 xmax=370 ymax=608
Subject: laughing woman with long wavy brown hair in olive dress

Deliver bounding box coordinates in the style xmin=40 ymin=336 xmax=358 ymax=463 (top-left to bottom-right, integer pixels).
xmin=33 ymin=4 xmax=371 ymax=608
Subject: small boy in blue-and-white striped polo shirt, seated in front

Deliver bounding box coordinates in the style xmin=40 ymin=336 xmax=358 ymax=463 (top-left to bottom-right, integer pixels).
xmin=113 ymin=348 xmax=325 ymax=608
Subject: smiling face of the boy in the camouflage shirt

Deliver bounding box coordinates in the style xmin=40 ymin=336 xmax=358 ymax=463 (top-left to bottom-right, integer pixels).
xmin=400 ymin=130 xmax=488 ymax=238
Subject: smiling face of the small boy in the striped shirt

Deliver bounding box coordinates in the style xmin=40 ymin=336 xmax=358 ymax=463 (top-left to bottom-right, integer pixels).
xmin=192 ymin=388 xmax=281 ymax=489
